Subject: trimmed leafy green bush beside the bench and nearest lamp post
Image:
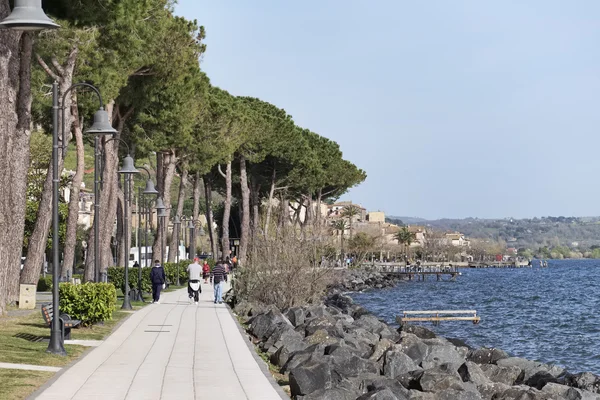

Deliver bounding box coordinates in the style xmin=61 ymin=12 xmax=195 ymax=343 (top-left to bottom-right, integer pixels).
xmin=58 ymin=282 xmax=117 ymax=325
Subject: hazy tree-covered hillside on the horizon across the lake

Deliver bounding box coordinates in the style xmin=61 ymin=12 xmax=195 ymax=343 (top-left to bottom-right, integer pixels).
xmin=390 ymin=217 xmax=600 ymax=251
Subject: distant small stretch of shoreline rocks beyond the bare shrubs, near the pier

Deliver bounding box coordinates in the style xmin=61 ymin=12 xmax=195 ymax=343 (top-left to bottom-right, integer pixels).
xmin=329 ymin=268 xmax=402 ymax=292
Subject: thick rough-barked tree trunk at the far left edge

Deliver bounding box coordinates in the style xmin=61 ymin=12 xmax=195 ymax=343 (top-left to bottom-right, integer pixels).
xmin=0 ymin=28 xmax=33 ymax=315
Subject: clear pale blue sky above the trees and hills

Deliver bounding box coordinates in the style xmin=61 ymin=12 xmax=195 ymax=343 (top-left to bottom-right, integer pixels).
xmin=176 ymin=0 xmax=600 ymax=218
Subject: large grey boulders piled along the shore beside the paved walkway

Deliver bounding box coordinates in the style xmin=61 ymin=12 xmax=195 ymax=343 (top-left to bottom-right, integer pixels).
xmin=236 ymin=293 xmax=600 ymax=400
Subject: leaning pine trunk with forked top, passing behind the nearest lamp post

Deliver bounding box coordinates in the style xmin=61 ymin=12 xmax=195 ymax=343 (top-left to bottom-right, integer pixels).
xmin=21 ymin=48 xmax=78 ymax=284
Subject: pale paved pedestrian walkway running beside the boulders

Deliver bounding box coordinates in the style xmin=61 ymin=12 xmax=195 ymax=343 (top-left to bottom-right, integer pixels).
xmin=32 ymin=284 xmax=288 ymax=400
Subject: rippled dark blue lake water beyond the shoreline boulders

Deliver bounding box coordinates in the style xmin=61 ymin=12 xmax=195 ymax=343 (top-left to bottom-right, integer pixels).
xmin=351 ymin=260 xmax=600 ymax=374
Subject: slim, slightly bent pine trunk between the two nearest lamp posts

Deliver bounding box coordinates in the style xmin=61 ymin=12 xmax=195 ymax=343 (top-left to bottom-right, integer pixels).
xmin=61 ymin=95 xmax=85 ymax=280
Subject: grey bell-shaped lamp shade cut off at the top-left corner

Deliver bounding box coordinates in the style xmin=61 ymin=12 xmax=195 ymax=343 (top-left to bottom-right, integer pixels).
xmin=0 ymin=0 xmax=60 ymax=31
